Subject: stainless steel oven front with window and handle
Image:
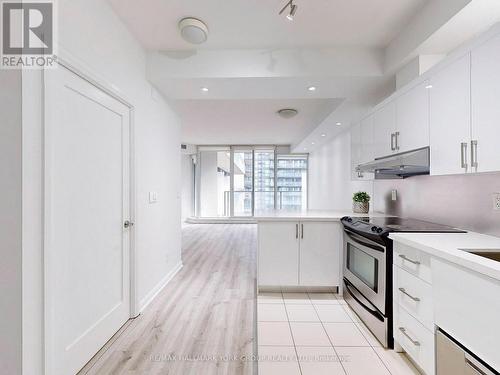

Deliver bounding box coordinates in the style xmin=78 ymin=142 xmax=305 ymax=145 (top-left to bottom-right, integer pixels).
xmin=343 ymin=229 xmax=393 ymax=347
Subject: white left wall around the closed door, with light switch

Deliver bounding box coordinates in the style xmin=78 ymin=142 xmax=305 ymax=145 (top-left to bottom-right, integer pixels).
xmin=22 ymin=0 xmax=181 ymax=375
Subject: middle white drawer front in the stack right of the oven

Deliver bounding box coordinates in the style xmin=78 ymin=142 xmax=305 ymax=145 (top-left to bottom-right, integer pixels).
xmin=394 ymin=266 xmax=434 ymax=331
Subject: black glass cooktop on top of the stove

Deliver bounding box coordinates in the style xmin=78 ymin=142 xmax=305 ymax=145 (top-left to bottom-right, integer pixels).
xmin=352 ymin=217 xmax=466 ymax=233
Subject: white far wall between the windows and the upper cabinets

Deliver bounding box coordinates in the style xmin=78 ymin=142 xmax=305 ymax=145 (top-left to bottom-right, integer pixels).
xmin=309 ymin=131 xmax=373 ymax=210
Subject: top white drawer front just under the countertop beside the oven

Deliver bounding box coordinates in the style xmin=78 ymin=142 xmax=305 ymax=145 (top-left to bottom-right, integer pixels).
xmin=393 ymin=242 xmax=432 ymax=284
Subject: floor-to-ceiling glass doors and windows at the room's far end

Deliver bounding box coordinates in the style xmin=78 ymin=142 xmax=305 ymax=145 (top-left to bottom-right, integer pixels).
xmin=195 ymin=146 xmax=308 ymax=218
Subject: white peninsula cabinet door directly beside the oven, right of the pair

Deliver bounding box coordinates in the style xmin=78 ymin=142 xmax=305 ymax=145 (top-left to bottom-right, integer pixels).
xmin=299 ymin=221 xmax=341 ymax=286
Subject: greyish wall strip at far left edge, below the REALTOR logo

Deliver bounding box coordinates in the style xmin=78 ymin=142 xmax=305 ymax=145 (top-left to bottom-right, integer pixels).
xmin=0 ymin=70 xmax=22 ymax=374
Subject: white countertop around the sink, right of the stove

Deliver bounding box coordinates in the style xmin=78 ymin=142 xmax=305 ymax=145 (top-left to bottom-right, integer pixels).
xmin=389 ymin=232 xmax=500 ymax=280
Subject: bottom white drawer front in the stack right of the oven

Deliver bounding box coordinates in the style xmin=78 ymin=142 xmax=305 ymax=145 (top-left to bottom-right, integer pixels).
xmin=394 ymin=306 xmax=435 ymax=375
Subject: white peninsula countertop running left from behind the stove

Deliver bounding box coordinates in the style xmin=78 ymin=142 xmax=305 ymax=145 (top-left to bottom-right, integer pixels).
xmin=254 ymin=210 xmax=391 ymax=222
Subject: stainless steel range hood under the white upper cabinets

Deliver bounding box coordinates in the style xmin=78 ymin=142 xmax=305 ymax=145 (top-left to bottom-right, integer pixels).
xmin=356 ymin=147 xmax=430 ymax=179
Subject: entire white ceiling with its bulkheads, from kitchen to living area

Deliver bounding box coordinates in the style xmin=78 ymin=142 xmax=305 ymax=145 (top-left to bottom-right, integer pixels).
xmin=107 ymin=0 xmax=500 ymax=152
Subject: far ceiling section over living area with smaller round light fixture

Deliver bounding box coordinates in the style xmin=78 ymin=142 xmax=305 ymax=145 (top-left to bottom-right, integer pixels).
xmin=171 ymin=99 xmax=342 ymax=145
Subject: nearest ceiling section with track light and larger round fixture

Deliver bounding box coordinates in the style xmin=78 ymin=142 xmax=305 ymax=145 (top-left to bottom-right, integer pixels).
xmin=108 ymin=0 xmax=426 ymax=50
